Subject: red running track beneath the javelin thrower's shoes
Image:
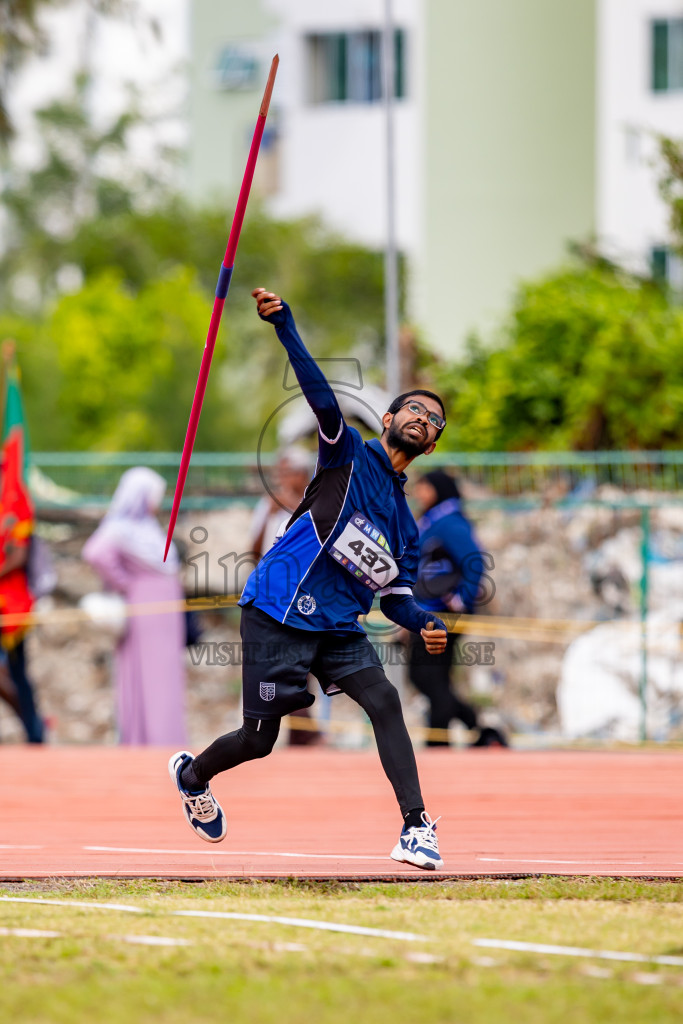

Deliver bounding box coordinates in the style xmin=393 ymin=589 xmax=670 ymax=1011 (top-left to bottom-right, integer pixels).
xmin=0 ymin=745 xmax=683 ymax=880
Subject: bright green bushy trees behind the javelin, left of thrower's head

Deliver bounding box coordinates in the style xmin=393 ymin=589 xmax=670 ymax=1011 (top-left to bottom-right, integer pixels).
xmin=0 ymin=200 xmax=383 ymax=451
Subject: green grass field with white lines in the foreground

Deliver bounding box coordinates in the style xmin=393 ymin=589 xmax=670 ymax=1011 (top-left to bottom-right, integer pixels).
xmin=0 ymin=879 xmax=683 ymax=1024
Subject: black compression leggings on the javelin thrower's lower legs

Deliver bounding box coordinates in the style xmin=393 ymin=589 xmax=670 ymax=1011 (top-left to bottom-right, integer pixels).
xmin=193 ymin=668 xmax=424 ymax=817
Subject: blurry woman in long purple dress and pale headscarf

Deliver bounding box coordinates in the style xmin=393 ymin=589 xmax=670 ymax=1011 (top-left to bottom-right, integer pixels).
xmin=83 ymin=466 xmax=186 ymax=746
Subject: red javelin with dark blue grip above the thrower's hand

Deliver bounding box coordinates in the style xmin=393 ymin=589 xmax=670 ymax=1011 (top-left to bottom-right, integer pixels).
xmin=164 ymin=53 xmax=280 ymax=561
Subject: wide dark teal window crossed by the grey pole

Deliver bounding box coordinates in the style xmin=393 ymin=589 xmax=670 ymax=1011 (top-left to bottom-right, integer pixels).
xmin=306 ymin=29 xmax=405 ymax=103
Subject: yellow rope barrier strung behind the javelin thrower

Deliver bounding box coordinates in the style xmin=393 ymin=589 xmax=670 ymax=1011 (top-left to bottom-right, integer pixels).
xmin=0 ymin=594 xmax=683 ymax=650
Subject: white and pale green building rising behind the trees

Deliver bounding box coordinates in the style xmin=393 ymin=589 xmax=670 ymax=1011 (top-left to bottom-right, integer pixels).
xmin=188 ymin=0 xmax=683 ymax=353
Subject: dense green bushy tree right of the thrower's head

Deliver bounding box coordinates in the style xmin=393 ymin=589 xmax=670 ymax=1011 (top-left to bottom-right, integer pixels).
xmin=436 ymin=263 xmax=683 ymax=451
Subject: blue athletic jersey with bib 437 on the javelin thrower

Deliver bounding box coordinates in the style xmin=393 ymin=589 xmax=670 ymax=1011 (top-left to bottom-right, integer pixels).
xmin=240 ymin=304 xmax=444 ymax=633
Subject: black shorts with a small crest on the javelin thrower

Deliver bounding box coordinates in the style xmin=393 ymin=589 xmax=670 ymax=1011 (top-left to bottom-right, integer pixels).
xmin=240 ymin=604 xmax=382 ymax=719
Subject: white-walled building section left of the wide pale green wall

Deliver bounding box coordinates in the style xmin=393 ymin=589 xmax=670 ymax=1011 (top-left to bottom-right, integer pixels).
xmin=188 ymin=0 xmax=420 ymax=251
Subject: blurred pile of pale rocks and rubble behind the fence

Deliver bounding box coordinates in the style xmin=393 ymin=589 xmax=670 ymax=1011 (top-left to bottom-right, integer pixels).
xmin=0 ymin=492 xmax=683 ymax=746
